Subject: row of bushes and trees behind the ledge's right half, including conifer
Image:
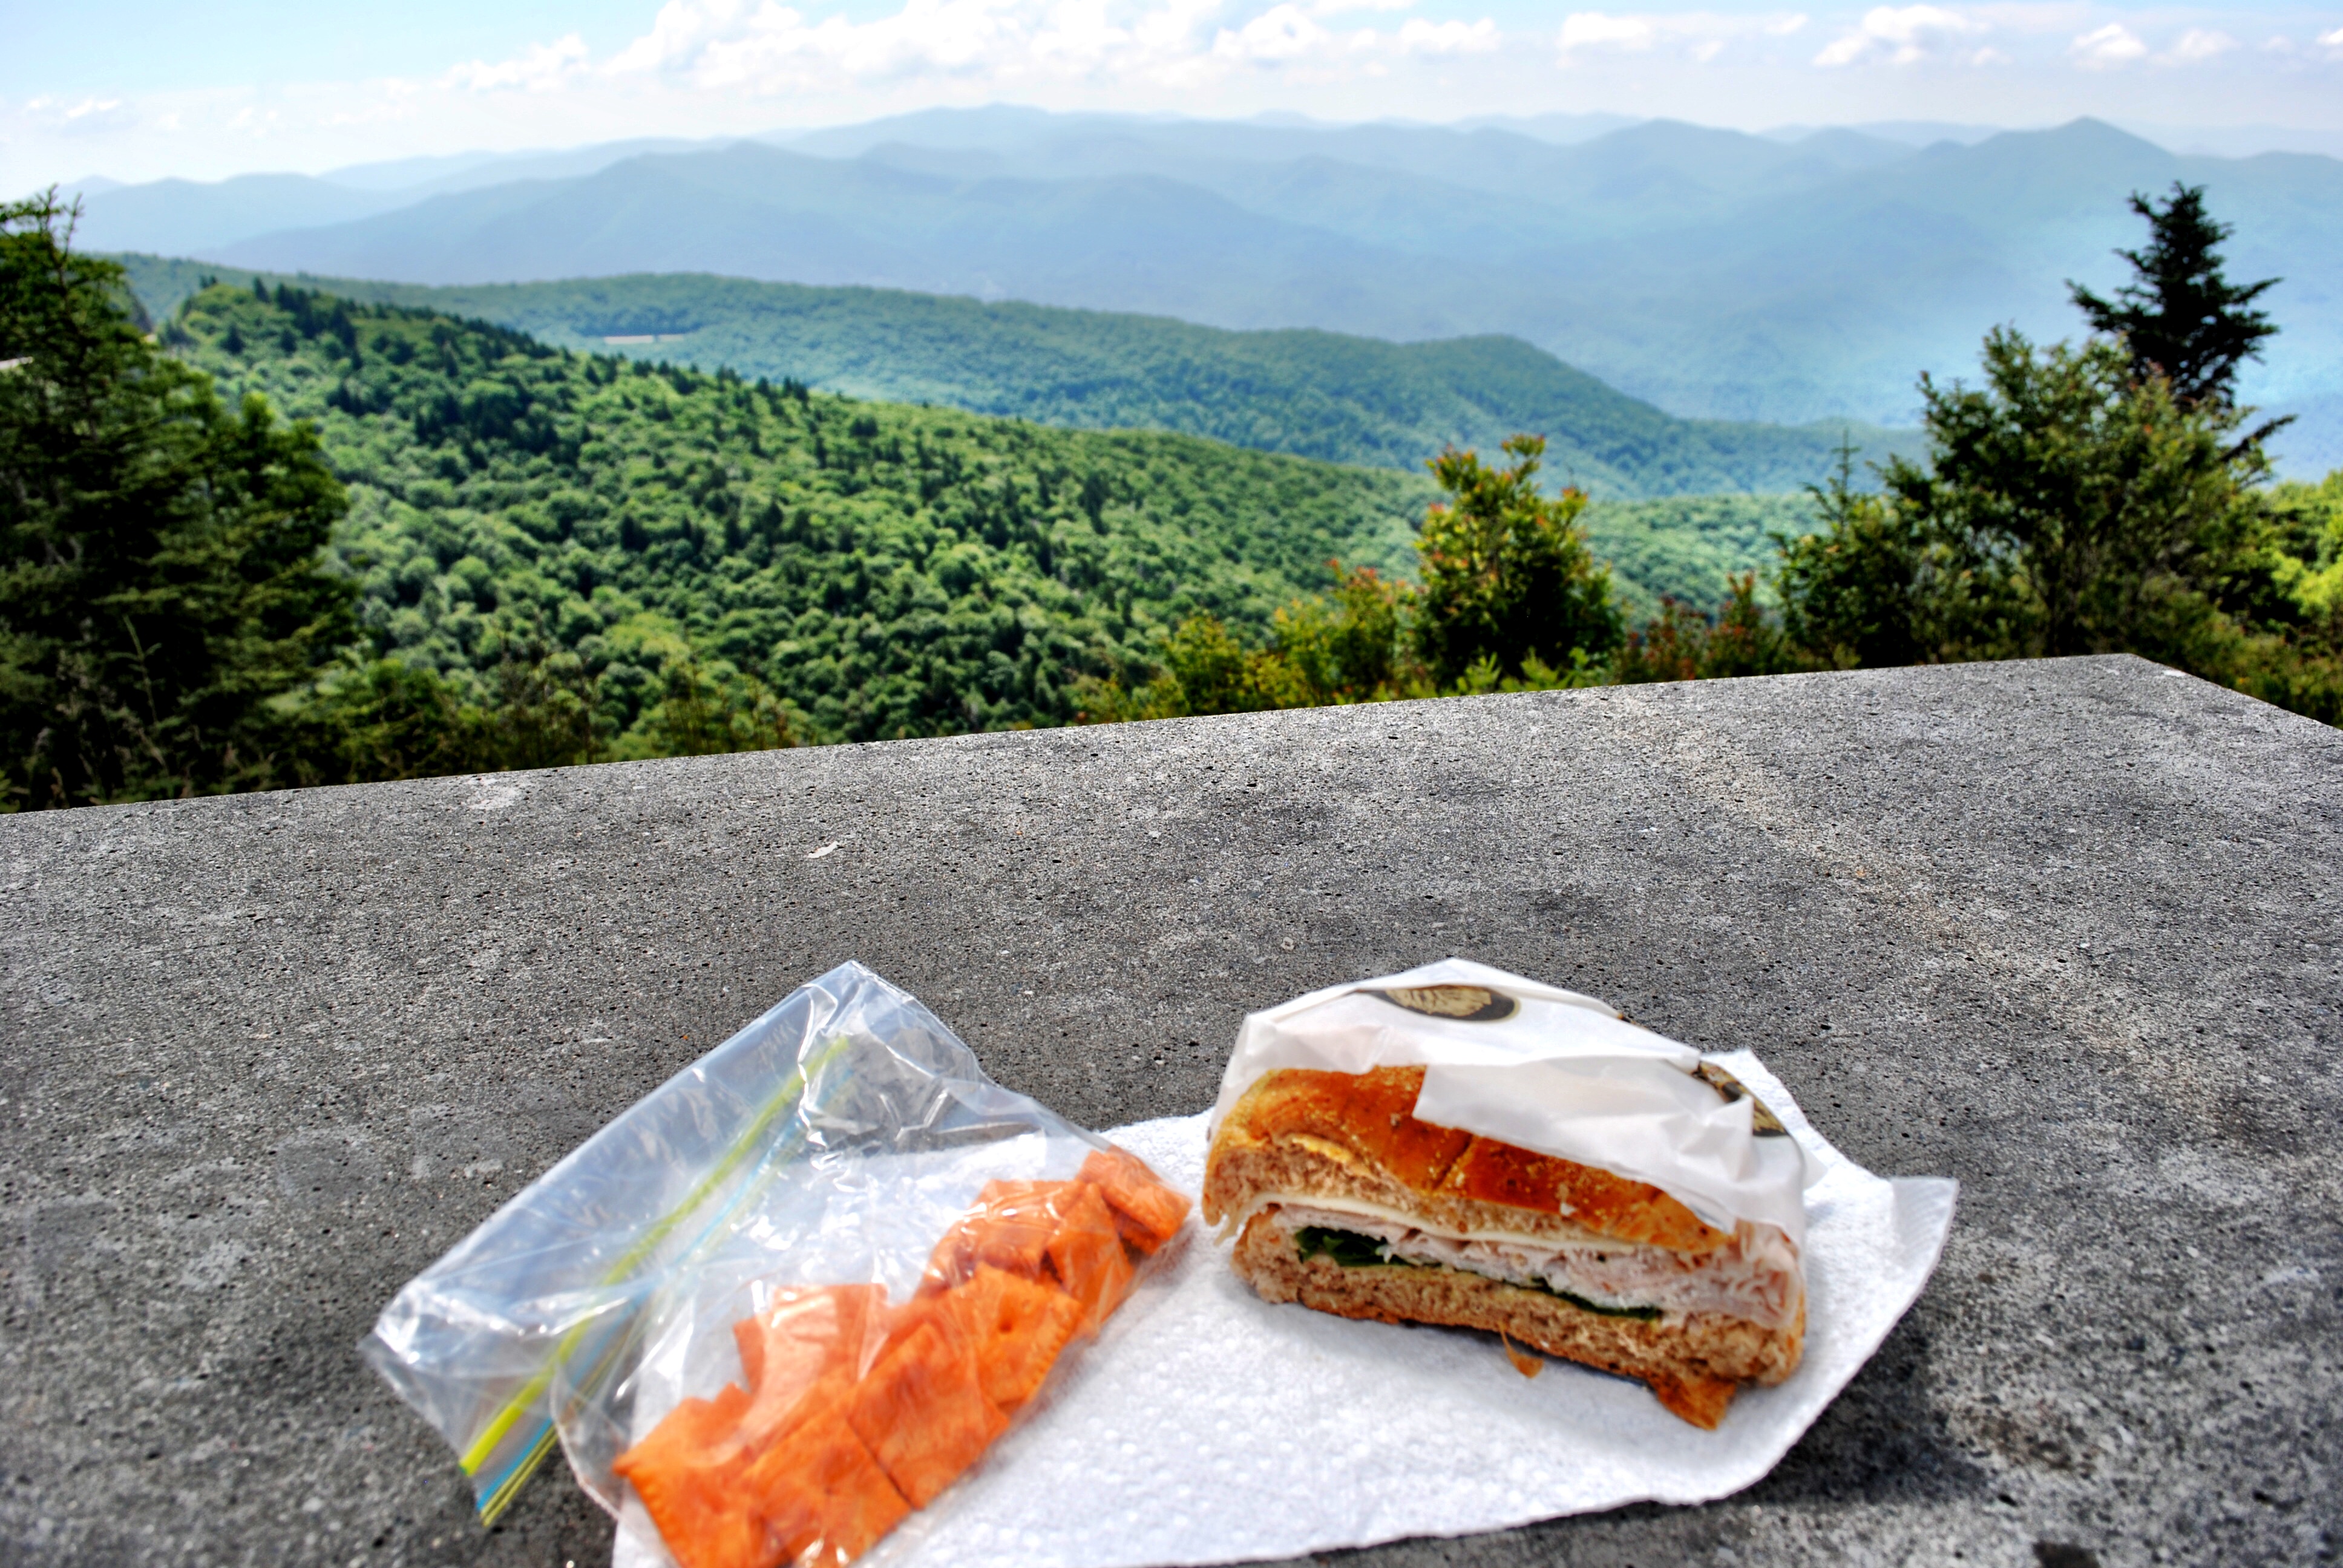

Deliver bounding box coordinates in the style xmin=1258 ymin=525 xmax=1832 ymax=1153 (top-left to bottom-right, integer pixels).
xmin=1092 ymin=185 xmax=2343 ymax=724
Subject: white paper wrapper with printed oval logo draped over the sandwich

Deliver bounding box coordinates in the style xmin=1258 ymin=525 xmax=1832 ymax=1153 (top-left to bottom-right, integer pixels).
xmin=1211 ymin=959 xmax=1818 ymax=1242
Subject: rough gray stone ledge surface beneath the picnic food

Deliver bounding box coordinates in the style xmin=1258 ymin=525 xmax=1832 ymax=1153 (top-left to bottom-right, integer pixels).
xmin=0 ymin=659 xmax=2343 ymax=1566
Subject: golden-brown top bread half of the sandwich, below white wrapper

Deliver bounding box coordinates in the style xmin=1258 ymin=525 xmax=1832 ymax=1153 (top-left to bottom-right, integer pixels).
xmin=1204 ymin=1067 xmax=1731 ymax=1254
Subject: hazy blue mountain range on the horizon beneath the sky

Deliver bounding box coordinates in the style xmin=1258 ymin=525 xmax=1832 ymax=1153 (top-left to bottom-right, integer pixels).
xmin=59 ymin=108 xmax=2343 ymax=471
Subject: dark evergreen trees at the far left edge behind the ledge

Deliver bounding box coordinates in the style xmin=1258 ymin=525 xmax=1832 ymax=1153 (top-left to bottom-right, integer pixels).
xmin=0 ymin=192 xmax=354 ymax=809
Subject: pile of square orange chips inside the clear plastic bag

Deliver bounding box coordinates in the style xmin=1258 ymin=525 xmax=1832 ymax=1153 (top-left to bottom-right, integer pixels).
xmin=614 ymin=1148 xmax=1188 ymax=1568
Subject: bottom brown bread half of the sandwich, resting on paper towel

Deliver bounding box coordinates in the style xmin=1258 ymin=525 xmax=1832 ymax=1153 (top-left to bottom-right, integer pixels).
xmin=1233 ymin=1212 xmax=1806 ymax=1429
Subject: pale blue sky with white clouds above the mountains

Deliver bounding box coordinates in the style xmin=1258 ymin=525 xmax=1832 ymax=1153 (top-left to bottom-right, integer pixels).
xmin=0 ymin=0 xmax=2343 ymax=190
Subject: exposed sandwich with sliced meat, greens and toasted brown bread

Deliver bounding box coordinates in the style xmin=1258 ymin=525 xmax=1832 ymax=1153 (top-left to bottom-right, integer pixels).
xmin=1204 ymin=1067 xmax=1806 ymax=1428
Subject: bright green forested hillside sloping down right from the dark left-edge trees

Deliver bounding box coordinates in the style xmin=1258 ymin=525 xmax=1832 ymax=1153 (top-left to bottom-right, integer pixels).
xmin=164 ymin=284 xmax=1432 ymax=753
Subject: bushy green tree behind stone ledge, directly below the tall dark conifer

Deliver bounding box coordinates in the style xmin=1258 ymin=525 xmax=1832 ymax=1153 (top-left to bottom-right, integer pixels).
xmin=1776 ymin=328 xmax=2266 ymax=675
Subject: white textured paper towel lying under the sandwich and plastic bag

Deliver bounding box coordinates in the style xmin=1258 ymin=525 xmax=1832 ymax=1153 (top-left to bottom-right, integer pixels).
xmin=616 ymin=1053 xmax=1954 ymax=1568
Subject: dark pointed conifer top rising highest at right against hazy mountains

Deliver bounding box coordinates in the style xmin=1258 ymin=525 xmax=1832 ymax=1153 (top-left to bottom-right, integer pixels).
xmin=2066 ymin=180 xmax=2279 ymax=412
